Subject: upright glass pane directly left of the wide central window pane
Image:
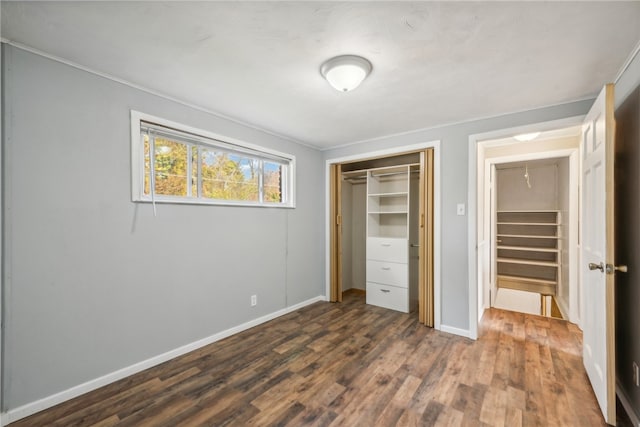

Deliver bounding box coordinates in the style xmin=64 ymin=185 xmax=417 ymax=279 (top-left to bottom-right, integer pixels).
xmin=154 ymin=137 xmax=187 ymax=196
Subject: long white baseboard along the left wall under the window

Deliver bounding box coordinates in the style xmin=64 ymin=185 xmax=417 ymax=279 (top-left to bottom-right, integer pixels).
xmin=0 ymin=296 xmax=325 ymax=426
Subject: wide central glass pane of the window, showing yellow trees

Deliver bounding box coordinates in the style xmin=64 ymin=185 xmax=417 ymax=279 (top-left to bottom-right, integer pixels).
xmin=201 ymin=148 xmax=259 ymax=201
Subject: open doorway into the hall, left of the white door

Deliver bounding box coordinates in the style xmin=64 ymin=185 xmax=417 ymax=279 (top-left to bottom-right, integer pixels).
xmin=478 ymin=126 xmax=580 ymax=323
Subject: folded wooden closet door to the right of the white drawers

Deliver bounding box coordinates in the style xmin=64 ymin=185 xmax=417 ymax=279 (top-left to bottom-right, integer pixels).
xmin=418 ymin=148 xmax=434 ymax=327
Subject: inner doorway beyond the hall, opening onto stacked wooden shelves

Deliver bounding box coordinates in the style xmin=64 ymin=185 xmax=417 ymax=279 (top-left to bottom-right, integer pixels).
xmin=489 ymin=157 xmax=579 ymax=319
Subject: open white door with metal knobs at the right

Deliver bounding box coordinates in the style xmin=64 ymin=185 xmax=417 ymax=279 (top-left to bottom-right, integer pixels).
xmin=580 ymin=84 xmax=616 ymax=425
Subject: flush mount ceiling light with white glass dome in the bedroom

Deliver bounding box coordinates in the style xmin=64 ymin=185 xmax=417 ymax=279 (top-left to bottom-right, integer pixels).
xmin=320 ymin=55 xmax=372 ymax=92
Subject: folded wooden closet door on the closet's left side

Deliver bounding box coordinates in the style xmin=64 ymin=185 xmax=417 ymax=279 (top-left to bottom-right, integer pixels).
xmin=329 ymin=164 xmax=342 ymax=302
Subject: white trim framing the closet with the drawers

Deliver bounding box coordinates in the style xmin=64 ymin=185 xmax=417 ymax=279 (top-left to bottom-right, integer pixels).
xmin=324 ymin=140 xmax=442 ymax=330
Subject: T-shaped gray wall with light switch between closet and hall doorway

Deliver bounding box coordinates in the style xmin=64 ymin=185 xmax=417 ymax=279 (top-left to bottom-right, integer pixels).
xmin=324 ymin=100 xmax=592 ymax=330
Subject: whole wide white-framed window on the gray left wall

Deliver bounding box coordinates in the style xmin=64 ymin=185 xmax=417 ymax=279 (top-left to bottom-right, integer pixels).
xmin=131 ymin=111 xmax=295 ymax=207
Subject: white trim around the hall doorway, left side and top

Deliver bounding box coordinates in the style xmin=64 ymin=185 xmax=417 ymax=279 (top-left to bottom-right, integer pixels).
xmin=467 ymin=115 xmax=585 ymax=339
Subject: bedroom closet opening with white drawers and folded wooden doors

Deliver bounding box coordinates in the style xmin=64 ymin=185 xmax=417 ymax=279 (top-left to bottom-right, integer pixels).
xmin=330 ymin=148 xmax=434 ymax=327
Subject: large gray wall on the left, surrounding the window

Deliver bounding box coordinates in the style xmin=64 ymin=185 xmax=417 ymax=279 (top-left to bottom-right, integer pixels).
xmin=2 ymin=45 xmax=324 ymax=410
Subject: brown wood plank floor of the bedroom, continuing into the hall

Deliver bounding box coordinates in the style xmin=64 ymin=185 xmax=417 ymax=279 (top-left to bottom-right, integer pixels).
xmin=11 ymin=295 xmax=604 ymax=427
